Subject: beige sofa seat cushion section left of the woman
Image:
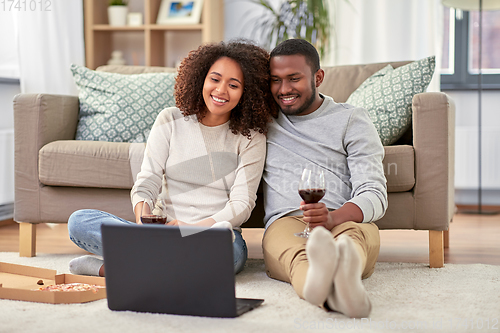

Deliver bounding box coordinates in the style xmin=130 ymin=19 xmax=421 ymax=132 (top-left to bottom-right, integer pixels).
xmin=38 ymin=140 xmax=145 ymax=189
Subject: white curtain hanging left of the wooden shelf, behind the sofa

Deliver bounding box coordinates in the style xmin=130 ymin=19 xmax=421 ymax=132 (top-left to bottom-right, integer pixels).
xmin=12 ymin=0 xmax=85 ymax=95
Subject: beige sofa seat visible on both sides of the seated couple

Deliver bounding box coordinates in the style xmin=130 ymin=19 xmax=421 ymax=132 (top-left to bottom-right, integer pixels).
xmin=39 ymin=140 xmax=415 ymax=192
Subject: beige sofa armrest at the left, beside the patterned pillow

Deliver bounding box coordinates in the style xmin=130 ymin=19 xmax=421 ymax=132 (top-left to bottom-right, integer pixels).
xmin=14 ymin=94 xmax=79 ymax=222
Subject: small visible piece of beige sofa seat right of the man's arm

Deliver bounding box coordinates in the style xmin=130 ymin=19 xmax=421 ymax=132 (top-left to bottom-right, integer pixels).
xmin=383 ymin=145 xmax=415 ymax=193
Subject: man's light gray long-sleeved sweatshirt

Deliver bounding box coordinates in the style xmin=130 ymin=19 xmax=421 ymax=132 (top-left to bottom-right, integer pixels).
xmin=264 ymin=95 xmax=387 ymax=228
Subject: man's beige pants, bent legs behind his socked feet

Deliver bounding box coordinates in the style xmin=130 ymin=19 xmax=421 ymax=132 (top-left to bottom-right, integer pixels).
xmin=262 ymin=216 xmax=380 ymax=298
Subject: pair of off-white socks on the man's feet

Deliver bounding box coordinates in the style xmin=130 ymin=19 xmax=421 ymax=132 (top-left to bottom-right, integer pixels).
xmin=302 ymin=227 xmax=371 ymax=318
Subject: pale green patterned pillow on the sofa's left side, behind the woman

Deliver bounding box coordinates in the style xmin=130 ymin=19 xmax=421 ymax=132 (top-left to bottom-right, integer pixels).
xmin=71 ymin=65 xmax=176 ymax=142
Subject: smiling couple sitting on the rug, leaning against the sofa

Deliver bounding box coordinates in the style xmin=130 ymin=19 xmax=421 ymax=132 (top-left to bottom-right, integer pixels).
xmin=68 ymin=39 xmax=387 ymax=318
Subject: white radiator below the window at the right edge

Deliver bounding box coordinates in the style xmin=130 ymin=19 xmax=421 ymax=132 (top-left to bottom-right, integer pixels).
xmin=455 ymin=126 xmax=500 ymax=190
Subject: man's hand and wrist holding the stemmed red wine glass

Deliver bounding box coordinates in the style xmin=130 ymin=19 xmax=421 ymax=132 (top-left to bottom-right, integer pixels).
xmin=300 ymin=201 xmax=363 ymax=230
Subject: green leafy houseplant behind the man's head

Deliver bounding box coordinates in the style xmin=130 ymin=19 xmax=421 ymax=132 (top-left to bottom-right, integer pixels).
xmin=244 ymin=0 xmax=349 ymax=57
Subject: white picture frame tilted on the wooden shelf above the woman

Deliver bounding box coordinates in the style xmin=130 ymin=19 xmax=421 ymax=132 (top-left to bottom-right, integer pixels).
xmin=156 ymin=0 xmax=203 ymax=25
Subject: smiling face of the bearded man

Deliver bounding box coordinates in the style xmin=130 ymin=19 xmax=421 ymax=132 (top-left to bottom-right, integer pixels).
xmin=270 ymin=55 xmax=321 ymax=116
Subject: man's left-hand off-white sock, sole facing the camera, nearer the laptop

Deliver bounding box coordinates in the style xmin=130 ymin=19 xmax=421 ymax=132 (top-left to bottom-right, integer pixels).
xmin=302 ymin=227 xmax=338 ymax=306
